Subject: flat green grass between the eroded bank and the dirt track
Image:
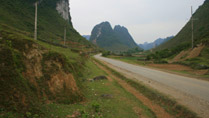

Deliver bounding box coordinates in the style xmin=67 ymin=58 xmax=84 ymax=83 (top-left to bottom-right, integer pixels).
xmin=39 ymin=61 xmax=156 ymax=118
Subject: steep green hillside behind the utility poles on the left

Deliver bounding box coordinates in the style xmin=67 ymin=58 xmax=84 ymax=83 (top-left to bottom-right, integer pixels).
xmin=0 ymin=0 xmax=92 ymax=47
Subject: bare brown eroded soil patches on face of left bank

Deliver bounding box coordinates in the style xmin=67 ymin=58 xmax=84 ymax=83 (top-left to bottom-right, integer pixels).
xmin=22 ymin=44 xmax=80 ymax=101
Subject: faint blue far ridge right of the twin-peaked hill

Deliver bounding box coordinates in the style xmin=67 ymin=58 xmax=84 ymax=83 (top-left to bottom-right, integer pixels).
xmin=139 ymin=36 xmax=174 ymax=50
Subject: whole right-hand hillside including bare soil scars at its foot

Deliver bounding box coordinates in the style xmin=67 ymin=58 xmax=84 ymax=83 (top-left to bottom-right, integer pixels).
xmin=147 ymin=0 xmax=209 ymax=71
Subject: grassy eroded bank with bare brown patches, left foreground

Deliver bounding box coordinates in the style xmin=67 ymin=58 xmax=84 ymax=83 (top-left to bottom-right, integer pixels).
xmin=0 ymin=28 xmax=84 ymax=118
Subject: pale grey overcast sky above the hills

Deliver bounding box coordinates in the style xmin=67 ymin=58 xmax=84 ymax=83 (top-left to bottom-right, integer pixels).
xmin=70 ymin=0 xmax=204 ymax=43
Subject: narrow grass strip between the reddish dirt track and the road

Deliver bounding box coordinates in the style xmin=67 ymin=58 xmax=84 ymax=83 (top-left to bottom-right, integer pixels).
xmin=95 ymin=60 xmax=198 ymax=118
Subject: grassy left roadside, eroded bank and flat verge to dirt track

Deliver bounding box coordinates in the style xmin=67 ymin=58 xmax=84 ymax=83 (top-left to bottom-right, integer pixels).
xmin=0 ymin=26 xmax=156 ymax=118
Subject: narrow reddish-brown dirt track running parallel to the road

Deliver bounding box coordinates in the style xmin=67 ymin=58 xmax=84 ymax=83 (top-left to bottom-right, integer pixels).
xmin=95 ymin=62 xmax=172 ymax=118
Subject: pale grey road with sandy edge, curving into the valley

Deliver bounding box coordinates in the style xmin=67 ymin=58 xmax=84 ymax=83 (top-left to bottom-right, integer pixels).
xmin=95 ymin=54 xmax=209 ymax=118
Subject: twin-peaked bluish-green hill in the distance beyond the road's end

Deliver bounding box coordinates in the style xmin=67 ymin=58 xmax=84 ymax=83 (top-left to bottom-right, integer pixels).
xmin=90 ymin=22 xmax=138 ymax=51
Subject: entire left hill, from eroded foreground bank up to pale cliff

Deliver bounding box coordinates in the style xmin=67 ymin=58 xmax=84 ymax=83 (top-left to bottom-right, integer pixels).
xmin=0 ymin=0 xmax=92 ymax=118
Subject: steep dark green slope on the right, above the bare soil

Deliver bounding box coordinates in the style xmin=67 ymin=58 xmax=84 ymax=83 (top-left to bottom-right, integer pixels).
xmin=156 ymin=0 xmax=209 ymax=50
